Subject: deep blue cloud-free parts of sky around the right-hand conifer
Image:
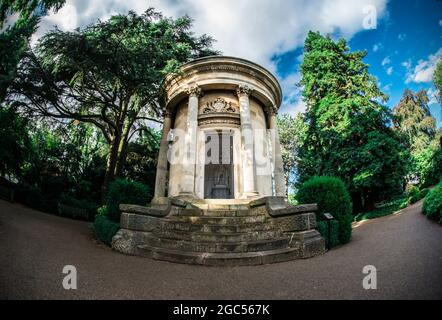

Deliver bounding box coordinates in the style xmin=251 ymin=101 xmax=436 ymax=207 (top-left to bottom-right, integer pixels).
xmin=273 ymin=0 xmax=442 ymax=127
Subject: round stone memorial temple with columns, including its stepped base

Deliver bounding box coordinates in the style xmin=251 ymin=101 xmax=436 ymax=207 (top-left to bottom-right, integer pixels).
xmin=112 ymin=56 xmax=325 ymax=265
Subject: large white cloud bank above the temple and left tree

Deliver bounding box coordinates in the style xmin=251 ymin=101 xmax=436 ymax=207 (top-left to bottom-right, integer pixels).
xmin=33 ymin=0 xmax=387 ymax=114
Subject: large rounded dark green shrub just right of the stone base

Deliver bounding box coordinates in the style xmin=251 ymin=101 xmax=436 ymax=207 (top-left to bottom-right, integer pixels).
xmin=296 ymin=176 xmax=353 ymax=244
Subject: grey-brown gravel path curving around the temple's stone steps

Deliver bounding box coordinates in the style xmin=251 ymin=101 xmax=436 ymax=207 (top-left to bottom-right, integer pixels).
xmin=0 ymin=200 xmax=442 ymax=299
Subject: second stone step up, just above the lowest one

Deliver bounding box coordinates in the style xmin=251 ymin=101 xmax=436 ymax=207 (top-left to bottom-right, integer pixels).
xmin=145 ymin=236 xmax=299 ymax=253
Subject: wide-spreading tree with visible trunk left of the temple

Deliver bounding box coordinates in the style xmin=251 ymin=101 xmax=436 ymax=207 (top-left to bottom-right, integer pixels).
xmin=9 ymin=8 xmax=217 ymax=200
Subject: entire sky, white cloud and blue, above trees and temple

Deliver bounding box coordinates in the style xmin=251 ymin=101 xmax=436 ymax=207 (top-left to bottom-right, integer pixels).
xmin=29 ymin=0 xmax=442 ymax=127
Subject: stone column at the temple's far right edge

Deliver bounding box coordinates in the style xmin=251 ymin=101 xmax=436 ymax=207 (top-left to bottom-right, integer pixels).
xmin=269 ymin=110 xmax=287 ymax=197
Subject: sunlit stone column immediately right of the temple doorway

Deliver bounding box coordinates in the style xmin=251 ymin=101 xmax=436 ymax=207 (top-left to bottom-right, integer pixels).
xmin=236 ymin=85 xmax=258 ymax=198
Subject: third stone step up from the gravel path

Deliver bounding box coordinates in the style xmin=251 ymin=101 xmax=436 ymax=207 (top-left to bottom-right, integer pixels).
xmin=153 ymin=229 xmax=284 ymax=243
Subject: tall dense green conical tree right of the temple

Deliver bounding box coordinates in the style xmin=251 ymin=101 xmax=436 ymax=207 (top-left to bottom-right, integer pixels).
xmin=298 ymin=32 xmax=405 ymax=210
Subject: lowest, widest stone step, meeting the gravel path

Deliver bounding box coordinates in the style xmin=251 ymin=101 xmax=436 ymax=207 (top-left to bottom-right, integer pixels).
xmin=136 ymin=245 xmax=303 ymax=266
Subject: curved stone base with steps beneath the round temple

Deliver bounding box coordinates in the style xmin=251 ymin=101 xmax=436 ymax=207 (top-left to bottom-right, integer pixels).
xmin=112 ymin=197 xmax=325 ymax=266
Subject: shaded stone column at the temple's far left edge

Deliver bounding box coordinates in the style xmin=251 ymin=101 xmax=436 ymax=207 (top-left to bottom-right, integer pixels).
xmin=155 ymin=111 xmax=172 ymax=198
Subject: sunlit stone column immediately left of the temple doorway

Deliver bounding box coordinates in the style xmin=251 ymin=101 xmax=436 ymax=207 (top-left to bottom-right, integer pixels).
xmin=180 ymin=85 xmax=201 ymax=197
